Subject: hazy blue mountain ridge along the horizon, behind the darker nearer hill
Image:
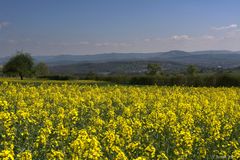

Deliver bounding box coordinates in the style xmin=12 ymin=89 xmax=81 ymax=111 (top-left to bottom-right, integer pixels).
xmin=0 ymin=50 xmax=240 ymax=68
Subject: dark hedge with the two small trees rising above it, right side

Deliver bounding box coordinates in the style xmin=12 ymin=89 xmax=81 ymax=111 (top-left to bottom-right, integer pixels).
xmin=86 ymin=63 xmax=240 ymax=87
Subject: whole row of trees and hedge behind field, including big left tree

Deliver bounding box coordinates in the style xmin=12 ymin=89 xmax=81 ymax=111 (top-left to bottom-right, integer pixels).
xmin=2 ymin=51 xmax=240 ymax=87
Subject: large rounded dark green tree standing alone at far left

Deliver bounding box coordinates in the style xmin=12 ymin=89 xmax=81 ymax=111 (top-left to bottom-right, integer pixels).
xmin=3 ymin=51 xmax=33 ymax=80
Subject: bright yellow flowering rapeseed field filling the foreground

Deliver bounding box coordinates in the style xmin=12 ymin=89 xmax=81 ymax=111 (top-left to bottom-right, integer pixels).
xmin=0 ymin=80 xmax=240 ymax=160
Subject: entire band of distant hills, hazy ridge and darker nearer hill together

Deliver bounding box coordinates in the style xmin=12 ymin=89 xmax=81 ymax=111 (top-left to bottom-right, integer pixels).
xmin=0 ymin=50 xmax=240 ymax=73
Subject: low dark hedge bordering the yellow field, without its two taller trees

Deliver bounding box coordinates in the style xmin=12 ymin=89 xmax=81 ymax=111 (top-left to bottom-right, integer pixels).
xmin=98 ymin=74 xmax=240 ymax=87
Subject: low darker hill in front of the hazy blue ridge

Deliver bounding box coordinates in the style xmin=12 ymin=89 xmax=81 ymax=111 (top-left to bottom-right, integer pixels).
xmin=50 ymin=61 xmax=185 ymax=74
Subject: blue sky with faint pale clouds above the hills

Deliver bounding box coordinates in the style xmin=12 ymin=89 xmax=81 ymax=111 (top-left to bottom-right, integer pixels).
xmin=0 ymin=0 xmax=240 ymax=56
